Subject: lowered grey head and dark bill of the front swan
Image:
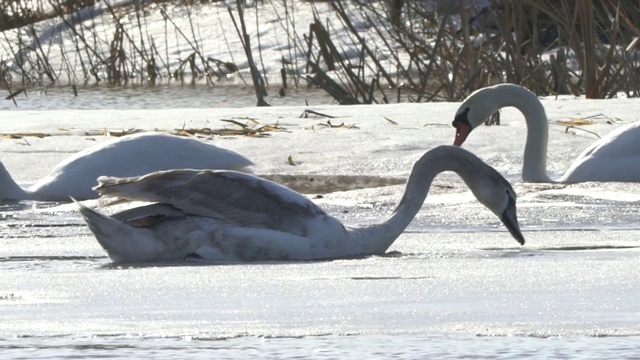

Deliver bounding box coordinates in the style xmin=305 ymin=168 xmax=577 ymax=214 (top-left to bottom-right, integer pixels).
xmin=465 ymin=165 xmax=524 ymax=245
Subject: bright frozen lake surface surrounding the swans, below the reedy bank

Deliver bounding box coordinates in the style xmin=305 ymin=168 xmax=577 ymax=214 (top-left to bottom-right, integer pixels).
xmin=0 ymin=93 xmax=640 ymax=359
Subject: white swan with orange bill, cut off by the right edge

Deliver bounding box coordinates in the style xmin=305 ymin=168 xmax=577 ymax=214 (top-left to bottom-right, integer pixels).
xmin=453 ymin=84 xmax=640 ymax=183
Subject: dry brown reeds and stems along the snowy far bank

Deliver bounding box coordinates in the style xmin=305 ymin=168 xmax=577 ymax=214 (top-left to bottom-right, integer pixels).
xmin=0 ymin=0 xmax=640 ymax=104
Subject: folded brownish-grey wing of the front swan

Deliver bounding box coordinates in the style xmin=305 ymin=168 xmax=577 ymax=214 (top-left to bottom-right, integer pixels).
xmin=94 ymin=170 xmax=326 ymax=233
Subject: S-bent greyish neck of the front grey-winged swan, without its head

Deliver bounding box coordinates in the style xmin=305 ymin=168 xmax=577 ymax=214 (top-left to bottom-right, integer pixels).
xmin=352 ymin=148 xmax=480 ymax=254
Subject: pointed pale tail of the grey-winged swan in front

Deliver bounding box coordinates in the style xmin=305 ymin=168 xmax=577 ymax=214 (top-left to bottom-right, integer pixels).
xmin=71 ymin=198 xmax=160 ymax=263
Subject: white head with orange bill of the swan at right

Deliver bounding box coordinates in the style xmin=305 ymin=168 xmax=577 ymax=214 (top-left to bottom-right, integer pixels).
xmin=451 ymin=87 xmax=500 ymax=146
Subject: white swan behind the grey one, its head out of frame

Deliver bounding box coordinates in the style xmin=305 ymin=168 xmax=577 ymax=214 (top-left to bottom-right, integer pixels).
xmin=0 ymin=132 xmax=253 ymax=201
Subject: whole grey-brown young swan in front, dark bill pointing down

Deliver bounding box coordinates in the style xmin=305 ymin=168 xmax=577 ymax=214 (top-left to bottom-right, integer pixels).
xmin=78 ymin=145 xmax=524 ymax=262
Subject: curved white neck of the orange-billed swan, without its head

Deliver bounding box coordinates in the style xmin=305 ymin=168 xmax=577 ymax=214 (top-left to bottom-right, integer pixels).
xmin=494 ymin=86 xmax=551 ymax=182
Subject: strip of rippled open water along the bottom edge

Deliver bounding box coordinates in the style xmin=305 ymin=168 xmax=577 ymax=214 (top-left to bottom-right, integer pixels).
xmin=0 ymin=334 xmax=640 ymax=359
